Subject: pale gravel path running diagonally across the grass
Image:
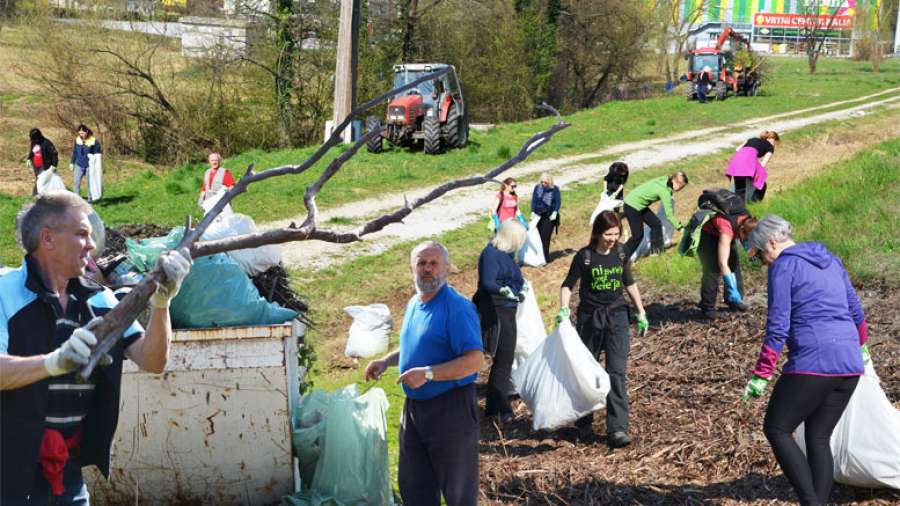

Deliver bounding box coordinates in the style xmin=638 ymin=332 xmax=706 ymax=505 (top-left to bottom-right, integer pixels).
xmin=262 ymin=88 xmax=900 ymax=269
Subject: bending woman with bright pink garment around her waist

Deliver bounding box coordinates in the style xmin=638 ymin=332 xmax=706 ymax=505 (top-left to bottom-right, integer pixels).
xmin=725 ymin=130 xmax=781 ymax=202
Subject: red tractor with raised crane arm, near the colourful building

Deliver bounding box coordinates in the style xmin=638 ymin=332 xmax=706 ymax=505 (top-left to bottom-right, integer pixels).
xmin=685 ymin=26 xmax=760 ymax=100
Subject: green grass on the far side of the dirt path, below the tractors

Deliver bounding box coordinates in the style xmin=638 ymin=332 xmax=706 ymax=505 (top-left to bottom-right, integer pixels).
xmin=0 ymin=45 xmax=900 ymax=262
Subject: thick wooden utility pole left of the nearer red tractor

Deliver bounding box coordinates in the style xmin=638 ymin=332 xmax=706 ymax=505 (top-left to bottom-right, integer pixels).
xmin=332 ymin=0 xmax=359 ymax=143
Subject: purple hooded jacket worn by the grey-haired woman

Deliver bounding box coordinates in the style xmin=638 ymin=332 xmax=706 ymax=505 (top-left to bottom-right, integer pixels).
xmin=753 ymin=242 xmax=867 ymax=378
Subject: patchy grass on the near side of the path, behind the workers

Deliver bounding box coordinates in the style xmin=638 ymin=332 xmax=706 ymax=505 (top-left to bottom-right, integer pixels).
xmin=304 ymin=115 xmax=900 ymax=494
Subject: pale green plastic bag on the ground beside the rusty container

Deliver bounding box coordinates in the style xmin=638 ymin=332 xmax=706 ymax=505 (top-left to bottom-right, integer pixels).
xmin=282 ymin=385 xmax=394 ymax=506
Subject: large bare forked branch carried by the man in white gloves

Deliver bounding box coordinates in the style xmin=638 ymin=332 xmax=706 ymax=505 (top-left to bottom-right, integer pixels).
xmin=78 ymin=69 xmax=569 ymax=381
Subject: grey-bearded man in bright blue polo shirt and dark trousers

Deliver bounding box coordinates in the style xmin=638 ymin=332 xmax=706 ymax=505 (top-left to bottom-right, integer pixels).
xmin=366 ymin=241 xmax=483 ymax=506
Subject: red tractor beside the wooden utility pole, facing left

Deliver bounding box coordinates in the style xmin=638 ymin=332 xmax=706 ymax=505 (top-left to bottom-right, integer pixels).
xmin=366 ymin=63 xmax=469 ymax=154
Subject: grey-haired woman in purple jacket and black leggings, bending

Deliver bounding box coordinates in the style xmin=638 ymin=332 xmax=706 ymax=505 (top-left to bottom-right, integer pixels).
xmin=743 ymin=215 xmax=868 ymax=505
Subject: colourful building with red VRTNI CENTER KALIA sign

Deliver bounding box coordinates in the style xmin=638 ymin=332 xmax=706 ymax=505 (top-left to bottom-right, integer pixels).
xmin=681 ymin=0 xmax=881 ymax=55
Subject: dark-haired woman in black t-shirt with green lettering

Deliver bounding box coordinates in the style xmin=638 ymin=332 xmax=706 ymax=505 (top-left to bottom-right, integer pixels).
xmin=556 ymin=211 xmax=649 ymax=448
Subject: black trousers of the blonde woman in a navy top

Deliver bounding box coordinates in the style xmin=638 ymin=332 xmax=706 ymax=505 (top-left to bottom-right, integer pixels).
xmin=484 ymin=306 xmax=517 ymax=416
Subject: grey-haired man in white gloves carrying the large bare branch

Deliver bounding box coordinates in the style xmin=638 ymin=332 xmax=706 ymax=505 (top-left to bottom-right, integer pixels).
xmin=0 ymin=192 xmax=190 ymax=506
